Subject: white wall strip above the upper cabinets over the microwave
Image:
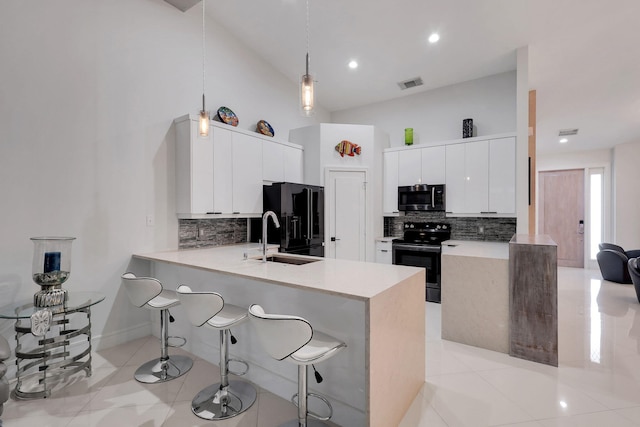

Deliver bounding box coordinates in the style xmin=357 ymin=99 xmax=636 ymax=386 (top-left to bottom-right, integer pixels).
xmin=331 ymin=71 xmax=516 ymax=147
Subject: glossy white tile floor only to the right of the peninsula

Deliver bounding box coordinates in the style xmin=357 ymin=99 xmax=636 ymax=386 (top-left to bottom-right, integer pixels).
xmin=401 ymin=267 xmax=640 ymax=427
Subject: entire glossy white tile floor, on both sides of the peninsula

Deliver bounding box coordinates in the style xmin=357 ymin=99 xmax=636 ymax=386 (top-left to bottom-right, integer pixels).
xmin=2 ymin=268 xmax=640 ymax=427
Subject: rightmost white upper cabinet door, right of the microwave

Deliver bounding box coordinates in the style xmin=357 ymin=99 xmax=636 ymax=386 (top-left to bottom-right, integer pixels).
xmin=489 ymin=137 xmax=516 ymax=214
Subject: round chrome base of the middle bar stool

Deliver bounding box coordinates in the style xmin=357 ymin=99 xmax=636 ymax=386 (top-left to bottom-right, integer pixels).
xmin=191 ymin=381 xmax=257 ymax=420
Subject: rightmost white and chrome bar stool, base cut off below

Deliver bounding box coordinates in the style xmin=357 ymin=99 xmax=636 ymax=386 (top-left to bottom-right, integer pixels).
xmin=249 ymin=304 xmax=347 ymax=427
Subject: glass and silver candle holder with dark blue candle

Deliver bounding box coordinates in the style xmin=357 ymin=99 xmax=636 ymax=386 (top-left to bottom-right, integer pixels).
xmin=31 ymin=237 xmax=76 ymax=307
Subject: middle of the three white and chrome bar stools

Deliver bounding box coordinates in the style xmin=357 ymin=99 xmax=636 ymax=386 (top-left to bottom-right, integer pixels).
xmin=176 ymin=285 xmax=257 ymax=420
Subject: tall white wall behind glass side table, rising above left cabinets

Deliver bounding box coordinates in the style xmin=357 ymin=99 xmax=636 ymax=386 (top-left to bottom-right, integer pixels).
xmin=0 ymin=0 xmax=329 ymax=352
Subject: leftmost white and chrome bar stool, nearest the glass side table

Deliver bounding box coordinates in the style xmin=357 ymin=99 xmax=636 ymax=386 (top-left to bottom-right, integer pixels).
xmin=122 ymin=273 xmax=193 ymax=384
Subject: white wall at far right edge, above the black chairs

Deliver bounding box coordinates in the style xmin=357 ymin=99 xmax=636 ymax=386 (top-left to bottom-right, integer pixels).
xmin=613 ymin=142 xmax=640 ymax=250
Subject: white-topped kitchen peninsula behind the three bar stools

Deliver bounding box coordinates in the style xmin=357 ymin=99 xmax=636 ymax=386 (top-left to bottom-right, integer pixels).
xmin=132 ymin=244 xmax=425 ymax=427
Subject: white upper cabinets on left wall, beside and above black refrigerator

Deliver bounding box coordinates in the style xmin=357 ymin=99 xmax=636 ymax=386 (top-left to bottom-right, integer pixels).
xmin=175 ymin=116 xmax=302 ymax=218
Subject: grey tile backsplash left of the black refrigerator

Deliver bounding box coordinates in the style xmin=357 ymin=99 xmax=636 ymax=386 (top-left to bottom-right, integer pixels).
xmin=178 ymin=218 xmax=247 ymax=249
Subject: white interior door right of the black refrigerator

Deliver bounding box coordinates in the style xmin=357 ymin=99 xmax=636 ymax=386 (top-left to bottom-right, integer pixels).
xmin=325 ymin=170 xmax=366 ymax=261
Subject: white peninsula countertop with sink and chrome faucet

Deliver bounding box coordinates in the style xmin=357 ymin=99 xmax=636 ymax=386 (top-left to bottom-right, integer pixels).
xmin=133 ymin=243 xmax=424 ymax=300
